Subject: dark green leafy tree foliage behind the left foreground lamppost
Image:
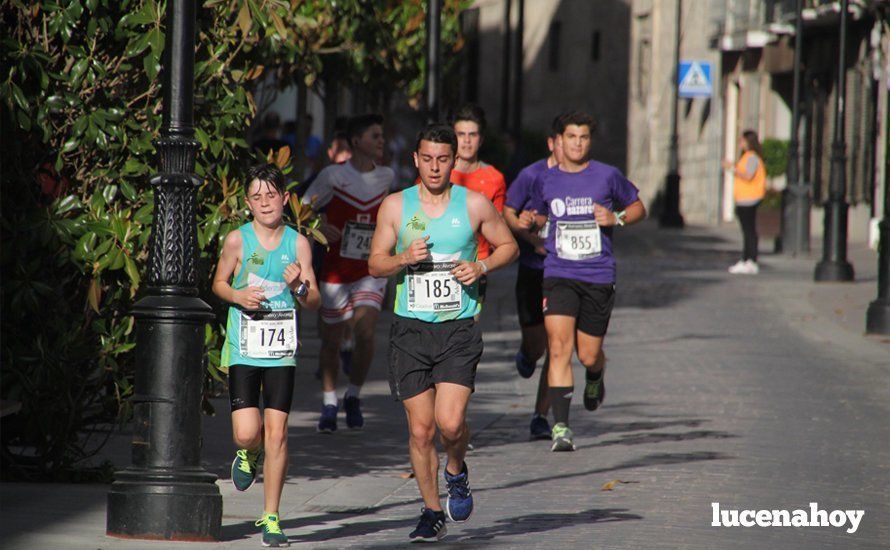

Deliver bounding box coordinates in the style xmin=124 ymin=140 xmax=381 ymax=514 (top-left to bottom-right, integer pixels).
xmin=0 ymin=0 xmax=467 ymax=478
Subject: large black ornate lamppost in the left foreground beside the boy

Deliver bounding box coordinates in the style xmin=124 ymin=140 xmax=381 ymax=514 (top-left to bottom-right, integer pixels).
xmin=106 ymin=0 xmax=222 ymax=540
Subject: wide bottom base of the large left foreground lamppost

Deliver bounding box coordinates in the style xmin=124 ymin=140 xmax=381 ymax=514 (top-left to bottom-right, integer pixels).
xmin=105 ymin=468 xmax=222 ymax=541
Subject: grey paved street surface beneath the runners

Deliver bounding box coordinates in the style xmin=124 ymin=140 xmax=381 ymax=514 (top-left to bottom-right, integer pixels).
xmin=0 ymin=222 xmax=890 ymax=549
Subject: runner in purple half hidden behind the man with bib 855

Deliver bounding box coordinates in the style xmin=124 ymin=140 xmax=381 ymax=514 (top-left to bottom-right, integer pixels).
xmin=504 ymin=117 xmax=562 ymax=439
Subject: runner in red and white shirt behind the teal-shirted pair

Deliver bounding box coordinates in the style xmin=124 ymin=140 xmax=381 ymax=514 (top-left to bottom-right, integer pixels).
xmin=303 ymin=114 xmax=395 ymax=433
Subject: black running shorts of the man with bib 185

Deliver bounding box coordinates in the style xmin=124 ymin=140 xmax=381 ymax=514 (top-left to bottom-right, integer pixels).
xmin=389 ymin=315 xmax=482 ymax=401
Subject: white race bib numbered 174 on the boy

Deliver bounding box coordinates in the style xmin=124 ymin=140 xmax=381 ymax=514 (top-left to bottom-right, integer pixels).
xmin=240 ymin=309 xmax=297 ymax=359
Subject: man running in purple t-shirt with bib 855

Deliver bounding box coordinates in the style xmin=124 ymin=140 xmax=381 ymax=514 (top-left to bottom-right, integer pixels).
xmin=531 ymin=112 xmax=646 ymax=451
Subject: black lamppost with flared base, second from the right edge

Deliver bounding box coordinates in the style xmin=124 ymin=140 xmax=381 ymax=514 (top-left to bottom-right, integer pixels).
xmin=815 ymin=0 xmax=853 ymax=281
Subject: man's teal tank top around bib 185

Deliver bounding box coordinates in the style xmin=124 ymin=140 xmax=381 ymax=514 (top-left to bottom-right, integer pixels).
xmin=394 ymin=184 xmax=481 ymax=323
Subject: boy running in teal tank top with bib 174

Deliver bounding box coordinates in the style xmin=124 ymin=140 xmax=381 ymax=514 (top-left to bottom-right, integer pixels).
xmin=213 ymin=164 xmax=321 ymax=547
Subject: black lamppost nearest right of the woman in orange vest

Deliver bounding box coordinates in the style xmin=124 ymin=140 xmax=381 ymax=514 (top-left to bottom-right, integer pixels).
xmin=782 ymin=0 xmax=810 ymax=256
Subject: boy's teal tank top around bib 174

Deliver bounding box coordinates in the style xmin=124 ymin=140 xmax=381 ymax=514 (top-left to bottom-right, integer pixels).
xmin=220 ymin=223 xmax=298 ymax=367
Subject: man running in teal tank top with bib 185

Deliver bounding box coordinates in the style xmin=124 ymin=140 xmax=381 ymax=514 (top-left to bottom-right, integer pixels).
xmin=368 ymin=124 xmax=519 ymax=541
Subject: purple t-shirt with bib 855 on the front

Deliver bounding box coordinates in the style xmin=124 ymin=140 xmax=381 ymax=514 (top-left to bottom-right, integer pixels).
xmin=529 ymin=160 xmax=639 ymax=284
